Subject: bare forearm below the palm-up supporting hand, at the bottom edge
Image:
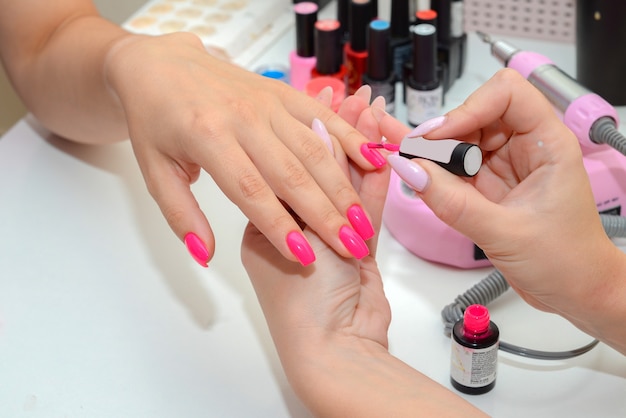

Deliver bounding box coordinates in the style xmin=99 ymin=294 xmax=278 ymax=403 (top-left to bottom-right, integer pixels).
xmin=279 ymin=336 xmax=485 ymax=417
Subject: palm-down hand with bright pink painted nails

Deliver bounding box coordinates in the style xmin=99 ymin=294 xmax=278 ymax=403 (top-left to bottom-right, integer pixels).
xmin=106 ymin=34 xmax=386 ymax=264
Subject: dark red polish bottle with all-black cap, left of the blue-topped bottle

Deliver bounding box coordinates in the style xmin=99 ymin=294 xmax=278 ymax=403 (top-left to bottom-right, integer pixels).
xmin=344 ymin=0 xmax=372 ymax=95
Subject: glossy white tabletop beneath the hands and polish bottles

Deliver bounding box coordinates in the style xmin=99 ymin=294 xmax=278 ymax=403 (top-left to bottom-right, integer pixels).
xmin=0 ymin=8 xmax=626 ymax=418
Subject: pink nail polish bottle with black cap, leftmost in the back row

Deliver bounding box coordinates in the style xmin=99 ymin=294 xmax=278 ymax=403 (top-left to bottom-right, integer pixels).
xmin=289 ymin=1 xmax=319 ymax=90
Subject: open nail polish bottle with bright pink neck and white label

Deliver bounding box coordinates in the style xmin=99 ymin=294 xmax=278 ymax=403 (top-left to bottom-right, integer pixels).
xmin=450 ymin=305 xmax=500 ymax=395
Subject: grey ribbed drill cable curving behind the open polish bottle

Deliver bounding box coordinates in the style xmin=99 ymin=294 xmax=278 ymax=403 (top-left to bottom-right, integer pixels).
xmin=441 ymin=214 xmax=626 ymax=360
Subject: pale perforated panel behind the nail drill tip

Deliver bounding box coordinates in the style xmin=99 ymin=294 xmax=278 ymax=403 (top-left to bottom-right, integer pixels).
xmin=465 ymin=0 xmax=572 ymax=43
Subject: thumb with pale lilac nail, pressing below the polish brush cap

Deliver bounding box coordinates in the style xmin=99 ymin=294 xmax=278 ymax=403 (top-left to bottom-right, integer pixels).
xmin=387 ymin=154 xmax=506 ymax=247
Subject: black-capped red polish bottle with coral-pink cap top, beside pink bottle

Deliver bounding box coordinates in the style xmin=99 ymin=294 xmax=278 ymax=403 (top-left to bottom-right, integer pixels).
xmin=311 ymin=19 xmax=346 ymax=83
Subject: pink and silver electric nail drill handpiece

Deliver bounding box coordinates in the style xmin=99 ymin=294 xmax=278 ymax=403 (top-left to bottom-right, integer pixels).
xmin=476 ymin=32 xmax=626 ymax=154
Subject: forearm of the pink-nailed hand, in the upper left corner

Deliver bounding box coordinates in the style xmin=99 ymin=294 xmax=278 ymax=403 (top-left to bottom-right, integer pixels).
xmin=0 ymin=1 xmax=128 ymax=143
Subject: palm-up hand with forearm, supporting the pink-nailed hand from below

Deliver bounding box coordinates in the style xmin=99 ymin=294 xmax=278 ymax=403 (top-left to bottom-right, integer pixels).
xmin=242 ymin=90 xmax=480 ymax=417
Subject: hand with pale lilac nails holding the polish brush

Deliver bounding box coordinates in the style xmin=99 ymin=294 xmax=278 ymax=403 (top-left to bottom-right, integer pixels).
xmin=380 ymin=70 xmax=626 ymax=353
